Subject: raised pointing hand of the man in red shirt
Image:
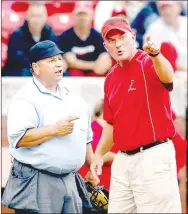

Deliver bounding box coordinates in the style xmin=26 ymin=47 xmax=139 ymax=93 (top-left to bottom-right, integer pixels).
xmin=143 ymin=36 xmax=161 ymax=55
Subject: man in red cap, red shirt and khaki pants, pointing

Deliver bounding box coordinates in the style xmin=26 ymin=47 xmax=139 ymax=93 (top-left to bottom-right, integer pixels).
xmin=90 ymin=17 xmax=181 ymax=213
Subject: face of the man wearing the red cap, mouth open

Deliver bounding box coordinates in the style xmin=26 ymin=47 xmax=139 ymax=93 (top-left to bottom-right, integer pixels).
xmin=104 ymin=29 xmax=135 ymax=61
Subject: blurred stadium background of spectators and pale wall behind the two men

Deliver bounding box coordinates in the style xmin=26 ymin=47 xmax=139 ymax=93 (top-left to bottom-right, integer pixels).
xmin=1 ymin=0 xmax=188 ymax=211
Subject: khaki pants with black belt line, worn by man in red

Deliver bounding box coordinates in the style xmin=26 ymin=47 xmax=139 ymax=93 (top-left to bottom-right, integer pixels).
xmin=108 ymin=140 xmax=181 ymax=213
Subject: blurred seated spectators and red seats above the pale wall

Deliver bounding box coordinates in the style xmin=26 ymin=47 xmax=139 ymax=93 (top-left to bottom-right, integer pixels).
xmin=2 ymin=1 xmax=187 ymax=76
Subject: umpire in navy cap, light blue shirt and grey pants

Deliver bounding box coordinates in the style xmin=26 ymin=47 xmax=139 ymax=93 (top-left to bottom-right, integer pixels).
xmin=2 ymin=40 xmax=97 ymax=214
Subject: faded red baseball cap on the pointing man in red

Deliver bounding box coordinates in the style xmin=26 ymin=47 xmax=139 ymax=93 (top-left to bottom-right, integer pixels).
xmin=101 ymin=17 xmax=132 ymax=39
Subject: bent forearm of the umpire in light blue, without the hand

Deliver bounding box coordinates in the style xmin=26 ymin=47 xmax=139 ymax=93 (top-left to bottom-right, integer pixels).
xmin=17 ymin=125 xmax=55 ymax=147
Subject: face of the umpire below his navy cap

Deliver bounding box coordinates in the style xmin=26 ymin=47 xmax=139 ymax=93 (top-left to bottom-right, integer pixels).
xmin=32 ymin=54 xmax=64 ymax=86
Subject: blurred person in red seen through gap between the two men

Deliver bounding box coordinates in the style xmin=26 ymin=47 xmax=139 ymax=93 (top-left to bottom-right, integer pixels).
xmin=79 ymin=99 xmax=117 ymax=190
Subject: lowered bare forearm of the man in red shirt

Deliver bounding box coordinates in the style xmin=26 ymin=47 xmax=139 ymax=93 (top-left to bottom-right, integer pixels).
xmin=95 ymin=122 xmax=114 ymax=156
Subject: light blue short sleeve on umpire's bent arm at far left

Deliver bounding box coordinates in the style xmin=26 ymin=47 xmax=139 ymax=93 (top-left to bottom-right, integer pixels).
xmin=7 ymin=99 xmax=39 ymax=148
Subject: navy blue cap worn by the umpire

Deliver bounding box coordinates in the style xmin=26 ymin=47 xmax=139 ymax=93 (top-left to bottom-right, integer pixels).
xmin=29 ymin=40 xmax=63 ymax=64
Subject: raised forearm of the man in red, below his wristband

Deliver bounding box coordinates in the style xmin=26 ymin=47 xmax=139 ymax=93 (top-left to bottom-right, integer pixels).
xmin=151 ymin=53 xmax=174 ymax=83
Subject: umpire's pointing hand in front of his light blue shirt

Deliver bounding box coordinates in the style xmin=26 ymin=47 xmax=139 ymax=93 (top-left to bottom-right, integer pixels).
xmin=53 ymin=116 xmax=80 ymax=136
